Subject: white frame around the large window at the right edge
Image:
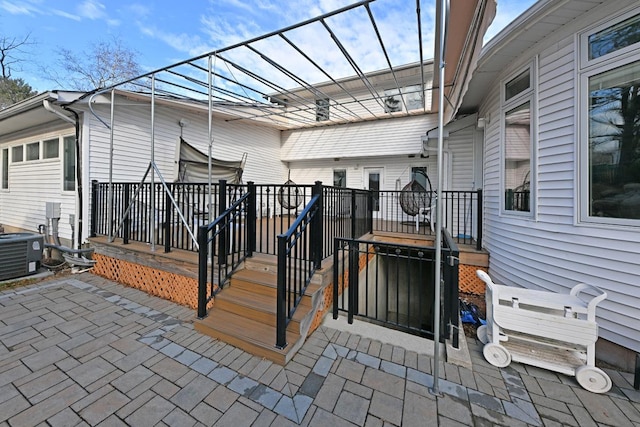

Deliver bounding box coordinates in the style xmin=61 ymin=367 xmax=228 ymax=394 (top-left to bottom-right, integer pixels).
xmin=577 ymin=8 xmax=640 ymax=227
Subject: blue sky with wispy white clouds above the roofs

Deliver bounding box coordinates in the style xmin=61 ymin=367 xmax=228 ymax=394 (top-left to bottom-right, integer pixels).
xmin=0 ymin=0 xmax=535 ymax=91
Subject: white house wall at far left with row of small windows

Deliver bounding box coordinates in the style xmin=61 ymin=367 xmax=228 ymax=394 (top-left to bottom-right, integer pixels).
xmin=0 ymin=121 xmax=76 ymax=240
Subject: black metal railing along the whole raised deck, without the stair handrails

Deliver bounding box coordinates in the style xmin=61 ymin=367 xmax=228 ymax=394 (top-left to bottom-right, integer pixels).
xmin=91 ymin=182 xmax=482 ymax=254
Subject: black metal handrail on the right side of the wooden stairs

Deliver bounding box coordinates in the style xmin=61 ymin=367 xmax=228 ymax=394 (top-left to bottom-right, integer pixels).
xmin=276 ymin=182 xmax=323 ymax=348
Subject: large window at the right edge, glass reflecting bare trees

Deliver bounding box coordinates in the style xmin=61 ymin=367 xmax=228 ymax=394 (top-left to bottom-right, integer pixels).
xmin=580 ymin=15 xmax=640 ymax=225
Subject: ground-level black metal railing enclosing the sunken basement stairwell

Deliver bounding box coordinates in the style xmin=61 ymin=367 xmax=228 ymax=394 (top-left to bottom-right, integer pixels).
xmin=333 ymin=230 xmax=458 ymax=347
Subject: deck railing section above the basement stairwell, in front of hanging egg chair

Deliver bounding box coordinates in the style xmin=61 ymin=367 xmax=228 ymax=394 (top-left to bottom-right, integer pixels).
xmin=372 ymin=190 xmax=482 ymax=249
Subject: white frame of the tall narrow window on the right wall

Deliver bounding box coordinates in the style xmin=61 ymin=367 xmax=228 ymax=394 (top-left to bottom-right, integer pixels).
xmin=500 ymin=62 xmax=538 ymax=218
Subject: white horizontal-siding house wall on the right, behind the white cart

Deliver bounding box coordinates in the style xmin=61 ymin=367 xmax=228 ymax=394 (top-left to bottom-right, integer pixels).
xmin=479 ymin=2 xmax=640 ymax=352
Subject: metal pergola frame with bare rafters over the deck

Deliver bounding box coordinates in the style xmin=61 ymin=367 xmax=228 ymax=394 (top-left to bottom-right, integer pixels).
xmin=76 ymin=0 xmax=432 ymax=130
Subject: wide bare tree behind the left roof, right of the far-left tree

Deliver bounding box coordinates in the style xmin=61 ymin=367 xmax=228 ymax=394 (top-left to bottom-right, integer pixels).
xmin=43 ymin=38 xmax=141 ymax=91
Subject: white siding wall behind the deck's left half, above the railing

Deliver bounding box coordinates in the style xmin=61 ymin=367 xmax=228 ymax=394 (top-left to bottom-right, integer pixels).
xmin=85 ymin=100 xmax=285 ymax=187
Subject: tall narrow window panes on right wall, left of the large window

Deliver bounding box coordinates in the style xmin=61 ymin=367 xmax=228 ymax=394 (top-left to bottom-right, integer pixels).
xmin=502 ymin=68 xmax=533 ymax=212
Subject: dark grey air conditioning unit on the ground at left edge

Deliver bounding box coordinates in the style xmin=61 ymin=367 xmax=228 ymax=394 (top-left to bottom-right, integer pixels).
xmin=0 ymin=233 xmax=44 ymax=280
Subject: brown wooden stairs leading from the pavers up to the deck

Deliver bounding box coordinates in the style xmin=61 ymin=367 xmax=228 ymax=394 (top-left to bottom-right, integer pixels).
xmin=195 ymin=255 xmax=322 ymax=364
